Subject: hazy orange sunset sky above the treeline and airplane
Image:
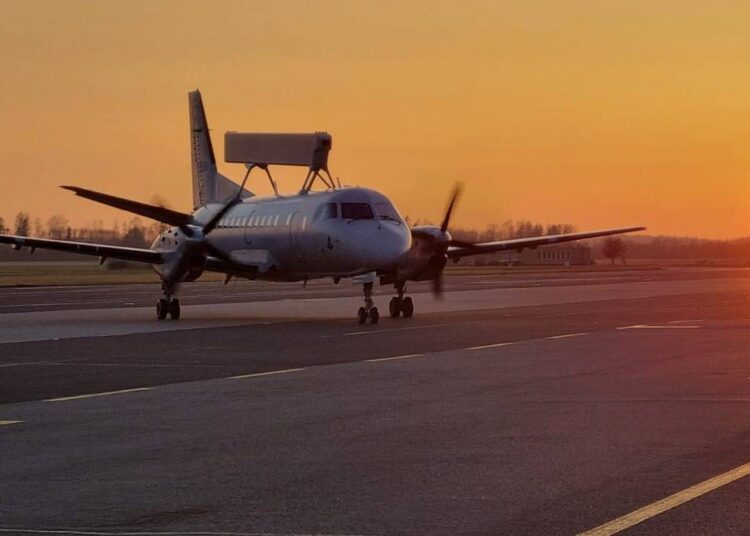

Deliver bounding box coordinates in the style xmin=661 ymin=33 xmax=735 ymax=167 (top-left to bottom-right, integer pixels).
xmin=0 ymin=0 xmax=750 ymax=238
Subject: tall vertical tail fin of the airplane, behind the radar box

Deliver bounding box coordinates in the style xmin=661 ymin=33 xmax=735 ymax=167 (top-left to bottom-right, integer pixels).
xmin=188 ymin=90 xmax=253 ymax=209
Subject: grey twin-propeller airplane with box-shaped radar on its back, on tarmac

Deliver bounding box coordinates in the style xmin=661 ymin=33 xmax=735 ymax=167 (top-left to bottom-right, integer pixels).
xmin=0 ymin=91 xmax=645 ymax=323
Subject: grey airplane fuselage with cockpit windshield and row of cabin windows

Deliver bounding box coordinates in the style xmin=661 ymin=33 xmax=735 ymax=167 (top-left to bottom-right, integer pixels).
xmin=152 ymin=188 xmax=412 ymax=281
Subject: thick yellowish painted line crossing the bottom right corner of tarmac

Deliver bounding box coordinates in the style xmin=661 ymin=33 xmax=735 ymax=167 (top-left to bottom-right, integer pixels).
xmin=579 ymin=463 xmax=750 ymax=536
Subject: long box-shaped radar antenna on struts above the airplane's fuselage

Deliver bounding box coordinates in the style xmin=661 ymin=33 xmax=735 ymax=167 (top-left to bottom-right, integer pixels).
xmin=224 ymin=132 xmax=341 ymax=196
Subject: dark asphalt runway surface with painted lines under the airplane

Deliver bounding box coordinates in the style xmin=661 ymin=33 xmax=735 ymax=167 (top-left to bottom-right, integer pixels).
xmin=0 ymin=269 xmax=750 ymax=535
